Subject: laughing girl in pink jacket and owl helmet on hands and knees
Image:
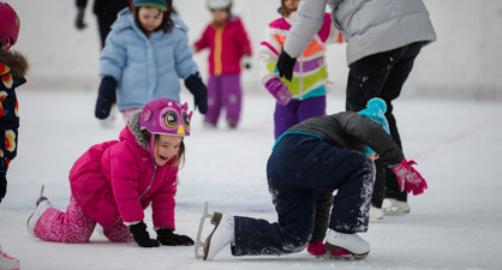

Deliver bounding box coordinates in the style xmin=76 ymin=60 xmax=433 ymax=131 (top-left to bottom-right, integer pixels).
xmin=28 ymin=98 xmax=193 ymax=247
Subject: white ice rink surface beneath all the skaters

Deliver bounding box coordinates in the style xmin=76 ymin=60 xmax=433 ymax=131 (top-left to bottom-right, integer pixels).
xmin=0 ymin=89 xmax=502 ymax=270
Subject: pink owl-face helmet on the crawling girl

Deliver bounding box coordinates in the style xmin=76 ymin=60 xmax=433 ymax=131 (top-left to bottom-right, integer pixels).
xmin=139 ymin=98 xmax=192 ymax=136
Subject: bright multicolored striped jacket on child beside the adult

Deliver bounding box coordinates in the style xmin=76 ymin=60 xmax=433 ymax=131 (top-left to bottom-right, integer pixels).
xmin=259 ymin=13 xmax=337 ymax=100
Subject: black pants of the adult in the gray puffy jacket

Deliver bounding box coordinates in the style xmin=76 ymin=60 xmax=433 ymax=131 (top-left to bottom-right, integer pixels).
xmin=346 ymin=42 xmax=424 ymax=207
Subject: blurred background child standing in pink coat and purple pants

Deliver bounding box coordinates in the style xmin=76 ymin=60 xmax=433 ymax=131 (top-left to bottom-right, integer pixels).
xmin=194 ymin=0 xmax=252 ymax=128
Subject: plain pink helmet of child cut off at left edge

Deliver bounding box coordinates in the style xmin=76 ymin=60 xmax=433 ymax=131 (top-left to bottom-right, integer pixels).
xmin=0 ymin=0 xmax=20 ymax=49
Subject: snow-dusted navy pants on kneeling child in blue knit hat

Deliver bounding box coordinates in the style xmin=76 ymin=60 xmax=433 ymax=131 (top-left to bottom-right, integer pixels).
xmin=232 ymin=134 xmax=375 ymax=256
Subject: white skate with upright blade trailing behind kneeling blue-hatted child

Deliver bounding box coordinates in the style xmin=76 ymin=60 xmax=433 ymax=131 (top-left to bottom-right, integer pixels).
xmin=195 ymin=202 xmax=235 ymax=261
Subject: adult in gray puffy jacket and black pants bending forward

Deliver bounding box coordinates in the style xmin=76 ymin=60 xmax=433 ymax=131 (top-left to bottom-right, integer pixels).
xmin=277 ymin=0 xmax=436 ymax=218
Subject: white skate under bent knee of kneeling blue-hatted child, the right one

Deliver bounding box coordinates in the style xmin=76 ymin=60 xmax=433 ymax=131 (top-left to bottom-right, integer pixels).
xmin=326 ymin=229 xmax=370 ymax=260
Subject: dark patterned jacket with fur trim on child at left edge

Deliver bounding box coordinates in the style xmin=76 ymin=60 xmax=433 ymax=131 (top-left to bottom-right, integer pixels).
xmin=0 ymin=50 xmax=27 ymax=175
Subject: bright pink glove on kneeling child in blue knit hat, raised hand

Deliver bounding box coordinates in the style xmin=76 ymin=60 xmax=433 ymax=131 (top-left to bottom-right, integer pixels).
xmin=391 ymin=159 xmax=427 ymax=195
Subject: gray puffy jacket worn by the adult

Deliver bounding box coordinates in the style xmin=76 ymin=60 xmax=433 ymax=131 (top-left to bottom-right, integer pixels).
xmin=284 ymin=0 xmax=436 ymax=65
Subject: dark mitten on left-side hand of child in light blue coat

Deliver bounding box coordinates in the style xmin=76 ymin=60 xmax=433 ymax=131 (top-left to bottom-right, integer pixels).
xmin=94 ymin=76 xmax=117 ymax=120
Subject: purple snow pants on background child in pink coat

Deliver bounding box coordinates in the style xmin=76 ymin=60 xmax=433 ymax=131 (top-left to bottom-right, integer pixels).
xmin=204 ymin=74 xmax=242 ymax=127
